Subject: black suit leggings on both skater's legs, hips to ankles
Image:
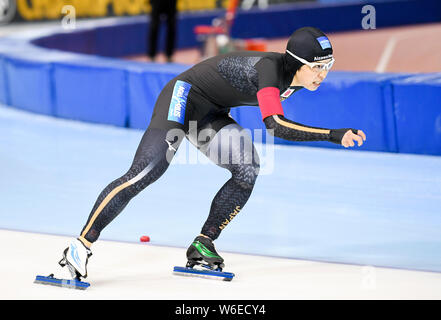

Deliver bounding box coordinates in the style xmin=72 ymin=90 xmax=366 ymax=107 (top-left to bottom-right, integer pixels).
xmin=80 ymin=81 xmax=259 ymax=244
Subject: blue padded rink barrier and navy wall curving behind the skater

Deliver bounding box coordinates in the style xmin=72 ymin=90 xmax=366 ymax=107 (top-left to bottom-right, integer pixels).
xmin=0 ymin=0 xmax=441 ymax=155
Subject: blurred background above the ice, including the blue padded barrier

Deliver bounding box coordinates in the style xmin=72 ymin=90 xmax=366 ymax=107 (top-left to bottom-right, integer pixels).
xmin=0 ymin=0 xmax=441 ymax=155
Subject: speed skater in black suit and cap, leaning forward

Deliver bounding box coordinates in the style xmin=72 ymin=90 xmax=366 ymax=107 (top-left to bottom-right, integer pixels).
xmin=55 ymin=27 xmax=366 ymax=279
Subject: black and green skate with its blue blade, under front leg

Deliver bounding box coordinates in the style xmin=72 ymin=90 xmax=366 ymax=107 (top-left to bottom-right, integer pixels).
xmin=173 ymin=236 xmax=234 ymax=281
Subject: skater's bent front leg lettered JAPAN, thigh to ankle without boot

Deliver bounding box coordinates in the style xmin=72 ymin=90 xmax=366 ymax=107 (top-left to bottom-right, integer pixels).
xmin=189 ymin=116 xmax=260 ymax=240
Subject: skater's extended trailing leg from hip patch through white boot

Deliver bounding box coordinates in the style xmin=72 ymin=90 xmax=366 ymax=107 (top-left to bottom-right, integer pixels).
xmin=55 ymin=79 xmax=191 ymax=278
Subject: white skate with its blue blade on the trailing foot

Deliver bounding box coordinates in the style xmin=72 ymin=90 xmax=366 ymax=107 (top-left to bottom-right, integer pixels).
xmin=34 ymin=239 xmax=92 ymax=290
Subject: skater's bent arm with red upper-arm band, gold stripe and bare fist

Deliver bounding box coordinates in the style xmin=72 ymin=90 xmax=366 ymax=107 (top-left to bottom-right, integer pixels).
xmin=257 ymin=87 xmax=366 ymax=148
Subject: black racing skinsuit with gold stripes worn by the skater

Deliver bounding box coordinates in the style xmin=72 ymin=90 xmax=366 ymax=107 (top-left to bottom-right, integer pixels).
xmin=79 ymin=51 xmax=336 ymax=245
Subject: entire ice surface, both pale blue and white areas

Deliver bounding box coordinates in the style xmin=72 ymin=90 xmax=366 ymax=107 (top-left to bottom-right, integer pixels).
xmin=0 ymin=106 xmax=441 ymax=299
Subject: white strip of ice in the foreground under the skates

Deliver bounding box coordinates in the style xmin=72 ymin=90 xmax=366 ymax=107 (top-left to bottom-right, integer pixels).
xmin=4 ymin=230 xmax=441 ymax=300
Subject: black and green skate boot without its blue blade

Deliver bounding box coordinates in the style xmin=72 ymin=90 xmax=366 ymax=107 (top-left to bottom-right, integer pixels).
xmin=187 ymin=236 xmax=225 ymax=271
